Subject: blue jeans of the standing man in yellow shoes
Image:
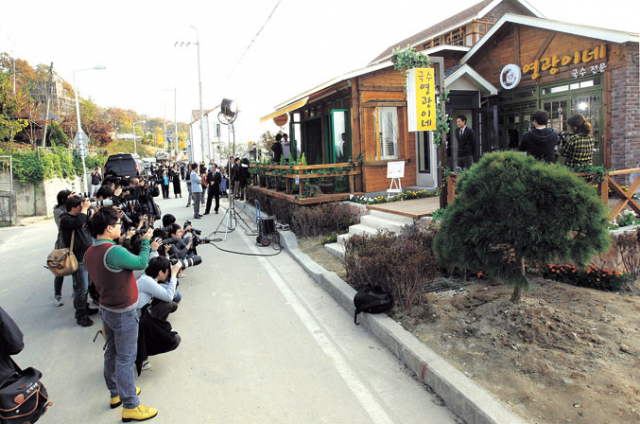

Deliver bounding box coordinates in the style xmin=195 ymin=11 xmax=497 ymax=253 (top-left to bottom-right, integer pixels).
xmin=100 ymin=307 xmax=140 ymax=409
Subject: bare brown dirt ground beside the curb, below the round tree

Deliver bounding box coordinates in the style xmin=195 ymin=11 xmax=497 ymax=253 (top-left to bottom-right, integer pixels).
xmin=299 ymin=240 xmax=640 ymax=424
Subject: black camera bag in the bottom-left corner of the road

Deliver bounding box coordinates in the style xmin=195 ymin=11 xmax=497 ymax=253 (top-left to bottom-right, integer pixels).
xmin=0 ymin=360 xmax=53 ymax=424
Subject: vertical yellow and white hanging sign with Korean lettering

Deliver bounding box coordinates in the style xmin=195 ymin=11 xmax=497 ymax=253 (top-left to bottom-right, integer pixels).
xmin=407 ymin=68 xmax=437 ymax=131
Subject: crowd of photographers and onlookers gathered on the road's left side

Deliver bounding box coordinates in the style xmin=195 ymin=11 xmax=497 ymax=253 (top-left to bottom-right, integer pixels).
xmin=45 ymin=158 xmax=238 ymax=421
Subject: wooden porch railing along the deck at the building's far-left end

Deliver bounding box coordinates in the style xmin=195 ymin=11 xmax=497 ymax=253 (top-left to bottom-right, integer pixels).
xmin=255 ymin=162 xmax=362 ymax=194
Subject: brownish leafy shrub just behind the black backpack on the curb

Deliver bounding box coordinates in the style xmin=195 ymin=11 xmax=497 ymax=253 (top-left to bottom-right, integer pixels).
xmin=345 ymin=230 xmax=438 ymax=310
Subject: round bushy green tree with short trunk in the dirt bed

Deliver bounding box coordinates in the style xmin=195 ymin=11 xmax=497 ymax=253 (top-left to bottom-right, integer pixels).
xmin=434 ymin=152 xmax=611 ymax=303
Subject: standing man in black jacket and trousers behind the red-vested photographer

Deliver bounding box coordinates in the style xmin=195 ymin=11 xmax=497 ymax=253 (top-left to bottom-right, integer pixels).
xmin=60 ymin=196 xmax=98 ymax=327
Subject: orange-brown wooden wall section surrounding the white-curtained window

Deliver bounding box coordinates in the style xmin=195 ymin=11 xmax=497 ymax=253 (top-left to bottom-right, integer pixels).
xmin=352 ymin=69 xmax=416 ymax=193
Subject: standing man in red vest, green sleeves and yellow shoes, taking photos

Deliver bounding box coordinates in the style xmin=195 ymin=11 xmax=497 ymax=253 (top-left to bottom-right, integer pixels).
xmin=85 ymin=207 xmax=158 ymax=422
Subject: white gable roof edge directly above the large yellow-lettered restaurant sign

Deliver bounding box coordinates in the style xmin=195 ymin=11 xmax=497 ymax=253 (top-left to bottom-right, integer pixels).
xmin=460 ymin=13 xmax=640 ymax=64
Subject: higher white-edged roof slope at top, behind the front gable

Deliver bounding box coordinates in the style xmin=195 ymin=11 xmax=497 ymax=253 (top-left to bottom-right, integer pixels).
xmin=371 ymin=0 xmax=544 ymax=64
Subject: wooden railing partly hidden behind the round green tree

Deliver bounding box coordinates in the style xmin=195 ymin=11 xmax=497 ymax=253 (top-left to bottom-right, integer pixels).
xmin=446 ymin=168 xmax=640 ymax=221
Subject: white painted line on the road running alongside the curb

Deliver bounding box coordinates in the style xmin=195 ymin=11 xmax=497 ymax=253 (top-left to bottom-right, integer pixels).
xmin=242 ymin=237 xmax=393 ymax=424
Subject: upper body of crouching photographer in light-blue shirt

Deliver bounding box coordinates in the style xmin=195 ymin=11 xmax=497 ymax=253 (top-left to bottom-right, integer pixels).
xmin=137 ymin=256 xmax=182 ymax=319
